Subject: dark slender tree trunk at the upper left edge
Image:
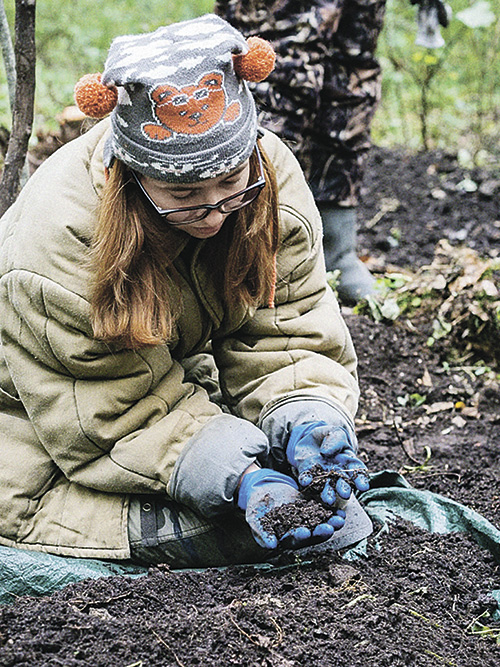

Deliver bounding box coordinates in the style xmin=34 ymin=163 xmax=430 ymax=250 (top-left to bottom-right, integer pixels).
xmin=0 ymin=0 xmax=36 ymax=215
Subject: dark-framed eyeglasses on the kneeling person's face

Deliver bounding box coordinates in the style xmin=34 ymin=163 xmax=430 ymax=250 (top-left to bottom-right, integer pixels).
xmin=131 ymin=145 xmax=266 ymax=225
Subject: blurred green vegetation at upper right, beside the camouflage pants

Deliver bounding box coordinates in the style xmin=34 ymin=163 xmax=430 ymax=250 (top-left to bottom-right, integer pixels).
xmin=373 ymin=0 xmax=500 ymax=159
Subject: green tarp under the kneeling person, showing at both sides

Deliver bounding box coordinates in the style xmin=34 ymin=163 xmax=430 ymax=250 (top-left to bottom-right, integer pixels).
xmin=0 ymin=470 xmax=500 ymax=620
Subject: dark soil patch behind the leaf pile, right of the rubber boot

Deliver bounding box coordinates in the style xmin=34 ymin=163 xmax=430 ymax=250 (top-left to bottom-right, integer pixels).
xmin=359 ymin=148 xmax=500 ymax=271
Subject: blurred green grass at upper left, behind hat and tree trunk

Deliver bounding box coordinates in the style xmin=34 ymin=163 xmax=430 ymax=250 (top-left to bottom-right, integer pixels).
xmin=0 ymin=0 xmax=213 ymax=128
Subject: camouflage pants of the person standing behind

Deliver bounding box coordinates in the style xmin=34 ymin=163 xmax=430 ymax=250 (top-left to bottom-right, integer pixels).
xmin=215 ymin=0 xmax=385 ymax=206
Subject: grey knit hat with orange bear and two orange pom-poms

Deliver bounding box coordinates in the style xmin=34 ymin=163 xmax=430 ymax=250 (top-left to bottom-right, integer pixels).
xmin=75 ymin=14 xmax=274 ymax=183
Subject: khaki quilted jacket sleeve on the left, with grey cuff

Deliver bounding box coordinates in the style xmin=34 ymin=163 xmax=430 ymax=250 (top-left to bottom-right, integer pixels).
xmin=0 ymin=270 xmax=268 ymax=513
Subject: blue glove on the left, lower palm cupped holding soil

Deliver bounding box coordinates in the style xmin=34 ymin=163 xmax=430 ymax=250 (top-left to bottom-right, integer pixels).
xmin=238 ymin=468 xmax=345 ymax=549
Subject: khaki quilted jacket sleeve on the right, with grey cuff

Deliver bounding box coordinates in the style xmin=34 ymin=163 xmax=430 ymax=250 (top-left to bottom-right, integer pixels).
xmin=214 ymin=135 xmax=358 ymax=456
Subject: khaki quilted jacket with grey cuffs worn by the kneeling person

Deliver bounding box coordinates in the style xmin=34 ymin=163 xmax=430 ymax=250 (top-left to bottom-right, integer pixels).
xmin=0 ymin=121 xmax=358 ymax=558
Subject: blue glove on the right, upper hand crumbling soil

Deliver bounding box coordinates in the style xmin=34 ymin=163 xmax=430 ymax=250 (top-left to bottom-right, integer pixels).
xmin=286 ymin=418 xmax=369 ymax=506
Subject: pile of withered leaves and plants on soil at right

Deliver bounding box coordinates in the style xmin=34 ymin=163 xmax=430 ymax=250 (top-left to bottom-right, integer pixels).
xmin=354 ymin=239 xmax=500 ymax=366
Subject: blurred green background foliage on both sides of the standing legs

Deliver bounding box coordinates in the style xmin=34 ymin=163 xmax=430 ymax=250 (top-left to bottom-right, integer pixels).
xmin=0 ymin=0 xmax=500 ymax=167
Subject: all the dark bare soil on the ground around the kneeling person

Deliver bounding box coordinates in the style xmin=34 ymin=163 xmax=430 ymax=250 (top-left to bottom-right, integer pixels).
xmin=0 ymin=138 xmax=500 ymax=667
